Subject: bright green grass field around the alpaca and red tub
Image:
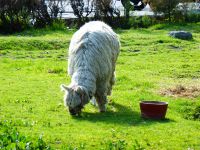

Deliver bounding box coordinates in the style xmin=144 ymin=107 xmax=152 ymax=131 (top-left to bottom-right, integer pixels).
xmin=0 ymin=24 xmax=200 ymax=150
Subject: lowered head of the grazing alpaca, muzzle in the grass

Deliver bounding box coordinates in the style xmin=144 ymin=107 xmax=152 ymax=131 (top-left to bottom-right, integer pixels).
xmin=61 ymin=84 xmax=89 ymax=115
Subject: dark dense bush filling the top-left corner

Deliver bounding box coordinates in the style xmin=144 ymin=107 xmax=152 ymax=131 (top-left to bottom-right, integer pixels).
xmin=0 ymin=0 xmax=40 ymax=32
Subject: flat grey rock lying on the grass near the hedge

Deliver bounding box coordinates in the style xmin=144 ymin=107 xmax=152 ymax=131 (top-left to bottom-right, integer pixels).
xmin=169 ymin=31 xmax=192 ymax=40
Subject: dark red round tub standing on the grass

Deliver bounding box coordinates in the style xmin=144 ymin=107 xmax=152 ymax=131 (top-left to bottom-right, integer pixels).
xmin=140 ymin=101 xmax=168 ymax=119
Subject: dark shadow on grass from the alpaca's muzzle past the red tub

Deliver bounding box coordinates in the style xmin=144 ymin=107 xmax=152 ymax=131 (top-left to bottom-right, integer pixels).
xmin=76 ymin=102 xmax=172 ymax=126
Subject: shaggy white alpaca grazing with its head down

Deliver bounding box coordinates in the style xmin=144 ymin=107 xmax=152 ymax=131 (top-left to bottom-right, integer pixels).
xmin=61 ymin=21 xmax=120 ymax=115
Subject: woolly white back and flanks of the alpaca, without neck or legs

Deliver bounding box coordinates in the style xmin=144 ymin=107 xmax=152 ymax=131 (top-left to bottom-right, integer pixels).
xmin=68 ymin=21 xmax=120 ymax=79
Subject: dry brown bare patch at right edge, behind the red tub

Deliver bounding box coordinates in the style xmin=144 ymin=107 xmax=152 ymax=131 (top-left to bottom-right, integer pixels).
xmin=160 ymin=85 xmax=200 ymax=98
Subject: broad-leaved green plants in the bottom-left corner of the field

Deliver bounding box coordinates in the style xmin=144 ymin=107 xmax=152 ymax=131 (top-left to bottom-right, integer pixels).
xmin=0 ymin=121 xmax=51 ymax=150
